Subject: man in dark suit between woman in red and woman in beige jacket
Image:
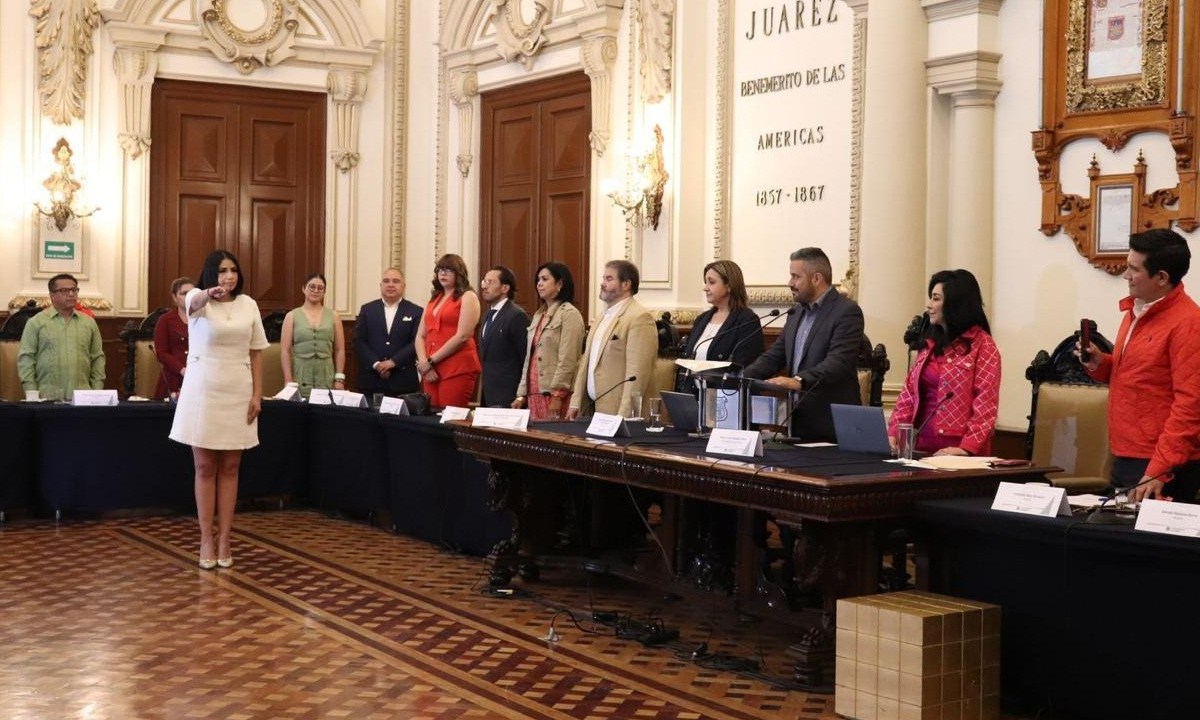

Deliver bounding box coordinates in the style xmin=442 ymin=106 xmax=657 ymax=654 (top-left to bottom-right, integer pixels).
xmin=476 ymin=265 xmax=529 ymax=408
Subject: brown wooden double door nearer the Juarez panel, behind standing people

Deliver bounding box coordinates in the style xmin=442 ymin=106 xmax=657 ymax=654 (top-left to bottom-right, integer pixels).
xmin=479 ymin=73 xmax=592 ymax=317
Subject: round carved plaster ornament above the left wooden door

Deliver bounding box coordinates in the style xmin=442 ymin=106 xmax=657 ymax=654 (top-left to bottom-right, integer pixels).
xmin=200 ymin=0 xmax=300 ymax=74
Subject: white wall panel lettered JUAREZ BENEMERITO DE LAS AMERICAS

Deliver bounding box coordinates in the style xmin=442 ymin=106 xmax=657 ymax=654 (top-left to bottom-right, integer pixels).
xmin=714 ymin=0 xmax=864 ymax=305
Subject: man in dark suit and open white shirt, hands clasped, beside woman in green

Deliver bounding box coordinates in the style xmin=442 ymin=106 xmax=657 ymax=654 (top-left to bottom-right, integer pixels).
xmin=354 ymin=268 xmax=421 ymax=396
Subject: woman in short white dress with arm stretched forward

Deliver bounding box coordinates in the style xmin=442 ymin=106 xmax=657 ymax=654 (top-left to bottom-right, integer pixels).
xmin=170 ymin=250 xmax=269 ymax=570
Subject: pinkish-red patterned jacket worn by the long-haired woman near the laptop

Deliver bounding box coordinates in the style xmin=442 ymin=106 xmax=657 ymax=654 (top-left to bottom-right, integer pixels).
xmin=888 ymin=325 xmax=1000 ymax=455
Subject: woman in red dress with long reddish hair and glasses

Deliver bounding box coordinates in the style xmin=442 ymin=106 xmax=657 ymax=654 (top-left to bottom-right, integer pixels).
xmin=414 ymin=254 xmax=481 ymax=408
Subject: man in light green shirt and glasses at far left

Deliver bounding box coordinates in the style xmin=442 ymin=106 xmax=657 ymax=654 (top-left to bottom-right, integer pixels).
xmin=17 ymin=272 xmax=104 ymax=400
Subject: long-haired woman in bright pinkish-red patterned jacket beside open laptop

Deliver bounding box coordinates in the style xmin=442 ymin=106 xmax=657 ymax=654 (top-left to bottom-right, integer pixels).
xmin=888 ymin=270 xmax=1000 ymax=455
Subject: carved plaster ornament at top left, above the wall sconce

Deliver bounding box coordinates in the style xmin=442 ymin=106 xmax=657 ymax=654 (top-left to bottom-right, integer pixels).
xmin=29 ymin=0 xmax=100 ymax=125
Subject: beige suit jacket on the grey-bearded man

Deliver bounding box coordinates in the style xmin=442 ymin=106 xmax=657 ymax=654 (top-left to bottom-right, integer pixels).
xmin=571 ymin=298 xmax=659 ymax=415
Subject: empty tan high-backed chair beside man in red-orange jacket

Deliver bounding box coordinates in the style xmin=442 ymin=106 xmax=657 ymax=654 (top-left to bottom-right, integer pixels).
xmin=1025 ymin=329 xmax=1112 ymax=492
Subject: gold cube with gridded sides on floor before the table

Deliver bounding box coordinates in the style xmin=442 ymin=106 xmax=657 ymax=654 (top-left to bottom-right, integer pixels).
xmin=834 ymin=592 xmax=1000 ymax=720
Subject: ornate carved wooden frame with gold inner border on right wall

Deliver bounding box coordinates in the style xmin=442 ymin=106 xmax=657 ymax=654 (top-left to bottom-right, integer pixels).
xmin=1032 ymin=0 xmax=1200 ymax=267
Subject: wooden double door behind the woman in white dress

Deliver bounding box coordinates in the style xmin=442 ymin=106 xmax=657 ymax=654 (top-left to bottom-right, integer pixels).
xmin=148 ymin=80 xmax=326 ymax=312
